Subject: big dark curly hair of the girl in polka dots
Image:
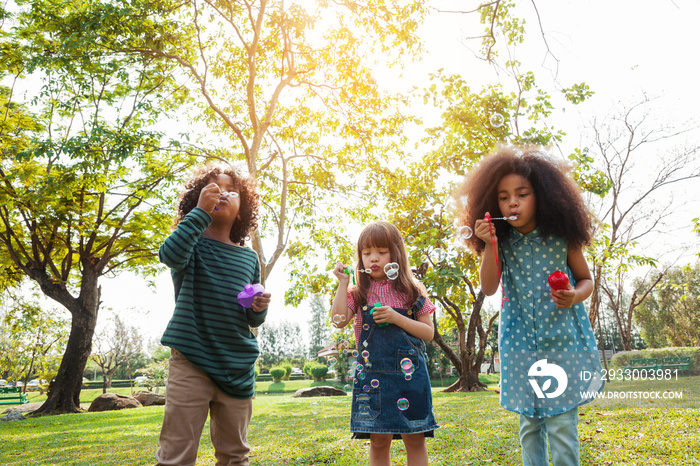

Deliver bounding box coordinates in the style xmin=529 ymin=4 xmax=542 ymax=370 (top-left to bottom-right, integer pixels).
xmin=454 ymin=147 xmax=593 ymax=254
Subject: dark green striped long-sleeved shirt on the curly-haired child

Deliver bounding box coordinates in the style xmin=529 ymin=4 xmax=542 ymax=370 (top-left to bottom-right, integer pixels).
xmin=158 ymin=208 xmax=267 ymax=398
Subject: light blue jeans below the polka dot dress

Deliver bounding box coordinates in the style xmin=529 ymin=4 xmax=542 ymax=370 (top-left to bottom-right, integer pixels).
xmin=520 ymin=408 xmax=581 ymax=466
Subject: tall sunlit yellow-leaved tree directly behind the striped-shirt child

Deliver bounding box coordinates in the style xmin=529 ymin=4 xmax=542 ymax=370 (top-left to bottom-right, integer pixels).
xmin=119 ymin=0 xmax=426 ymax=283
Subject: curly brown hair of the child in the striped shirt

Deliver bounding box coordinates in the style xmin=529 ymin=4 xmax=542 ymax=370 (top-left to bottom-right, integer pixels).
xmin=175 ymin=165 xmax=260 ymax=246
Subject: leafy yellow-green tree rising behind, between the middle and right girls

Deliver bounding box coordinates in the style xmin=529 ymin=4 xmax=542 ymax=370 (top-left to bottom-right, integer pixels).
xmin=278 ymin=2 xmax=591 ymax=391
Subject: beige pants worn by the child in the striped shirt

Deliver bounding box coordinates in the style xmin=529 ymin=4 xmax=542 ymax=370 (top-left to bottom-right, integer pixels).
xmin=156 ymin=349 xmax=253 ymax=466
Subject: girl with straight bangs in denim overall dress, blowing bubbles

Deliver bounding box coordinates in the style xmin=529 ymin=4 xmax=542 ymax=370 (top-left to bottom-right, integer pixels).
xmin=332 ymin=222 xmax=439 ymax=466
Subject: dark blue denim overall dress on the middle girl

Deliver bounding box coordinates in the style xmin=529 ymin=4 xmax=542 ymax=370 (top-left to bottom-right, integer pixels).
xmin=350 ymin=297 xmax=439 ymax=439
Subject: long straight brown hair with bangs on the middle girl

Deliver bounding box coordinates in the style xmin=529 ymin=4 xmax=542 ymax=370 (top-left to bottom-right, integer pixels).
xmin=353 ymin=222 xmax=427 ymax=307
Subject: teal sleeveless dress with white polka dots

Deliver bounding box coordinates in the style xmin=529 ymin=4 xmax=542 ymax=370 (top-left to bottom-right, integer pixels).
xmin=498 ymin=228 xmax=604 ymax=417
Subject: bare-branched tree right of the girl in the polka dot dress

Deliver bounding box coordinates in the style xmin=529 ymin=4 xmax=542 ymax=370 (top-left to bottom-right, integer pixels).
xmin=581 ymin=99 xmax=700 ymax=350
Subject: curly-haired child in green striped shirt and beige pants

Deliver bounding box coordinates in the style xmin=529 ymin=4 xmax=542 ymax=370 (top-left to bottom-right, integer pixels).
xmin=156 ymin=167 xmax=270 ymax=466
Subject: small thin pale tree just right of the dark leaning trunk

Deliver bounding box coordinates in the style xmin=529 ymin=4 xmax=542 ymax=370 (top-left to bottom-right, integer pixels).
xmin=90 ymin=314 xmax=143 ymax=393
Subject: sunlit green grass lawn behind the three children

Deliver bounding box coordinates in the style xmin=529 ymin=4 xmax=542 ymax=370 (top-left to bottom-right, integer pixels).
xmin=0 ymin=377 xmax=700 ymax=466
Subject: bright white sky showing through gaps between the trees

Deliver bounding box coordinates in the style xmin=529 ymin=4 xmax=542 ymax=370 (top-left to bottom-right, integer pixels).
xmin=102 ymin=0 xmax=700 ymax=346
